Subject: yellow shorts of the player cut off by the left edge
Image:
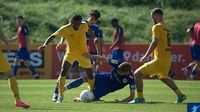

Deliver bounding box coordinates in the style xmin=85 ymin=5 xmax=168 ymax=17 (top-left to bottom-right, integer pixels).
xmin=0 ymin=51 xmax=11 ymax=72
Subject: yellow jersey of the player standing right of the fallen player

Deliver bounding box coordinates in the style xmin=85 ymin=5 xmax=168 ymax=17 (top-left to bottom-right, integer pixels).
xmin=152 ymin=23 xmax=171 ymax=62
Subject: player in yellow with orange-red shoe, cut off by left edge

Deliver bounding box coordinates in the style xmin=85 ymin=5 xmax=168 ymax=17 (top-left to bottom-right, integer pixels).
xmin=0 ymin=17 xmax=30 ymax=108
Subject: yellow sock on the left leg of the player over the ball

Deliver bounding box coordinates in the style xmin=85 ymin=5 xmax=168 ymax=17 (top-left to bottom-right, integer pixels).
xmin=58 ymin=76 xmax=66 ymax=97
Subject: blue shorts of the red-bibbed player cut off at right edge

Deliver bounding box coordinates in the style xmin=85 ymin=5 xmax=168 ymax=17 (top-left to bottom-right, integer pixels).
xmin=190 ymin=45 xmax=200 ymax=61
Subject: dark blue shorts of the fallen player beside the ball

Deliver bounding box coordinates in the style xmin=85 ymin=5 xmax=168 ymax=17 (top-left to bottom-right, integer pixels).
xmin=93 ymin=74 xmax=110 ymax=100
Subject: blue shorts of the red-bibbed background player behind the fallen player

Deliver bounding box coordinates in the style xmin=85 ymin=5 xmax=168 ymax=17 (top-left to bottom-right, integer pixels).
xmin=112 ymin=50 xmax=124 ymax=61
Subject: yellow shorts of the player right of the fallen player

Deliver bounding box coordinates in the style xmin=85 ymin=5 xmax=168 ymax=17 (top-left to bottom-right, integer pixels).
xmin=138 ymin=59 xmax=171 ymax=79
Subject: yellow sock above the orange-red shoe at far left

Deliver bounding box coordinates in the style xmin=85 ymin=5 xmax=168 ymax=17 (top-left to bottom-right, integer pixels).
xmin=8 ymin=77 xmax=20 ymax=100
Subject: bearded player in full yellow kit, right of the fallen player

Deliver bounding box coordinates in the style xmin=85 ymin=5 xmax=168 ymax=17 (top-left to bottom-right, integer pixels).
xmin=130 ymin=8 xmax=186 ymax=103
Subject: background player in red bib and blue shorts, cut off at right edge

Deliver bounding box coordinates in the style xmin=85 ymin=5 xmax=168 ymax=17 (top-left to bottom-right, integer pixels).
xmin=181 ymin=22 xmax=200 ymax=80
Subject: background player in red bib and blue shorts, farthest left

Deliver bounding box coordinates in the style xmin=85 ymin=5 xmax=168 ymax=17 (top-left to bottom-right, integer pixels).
xmin=9 ymin=16 xmax=40 ymax=79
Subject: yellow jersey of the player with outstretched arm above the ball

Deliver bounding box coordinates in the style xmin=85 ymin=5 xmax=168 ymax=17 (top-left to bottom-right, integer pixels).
xmin=53 ymin=23 xmax=89 ymax=55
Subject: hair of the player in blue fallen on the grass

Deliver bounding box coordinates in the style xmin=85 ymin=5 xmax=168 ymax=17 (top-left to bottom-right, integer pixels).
xmin=118 ymin=62 xmax=132 ymax=72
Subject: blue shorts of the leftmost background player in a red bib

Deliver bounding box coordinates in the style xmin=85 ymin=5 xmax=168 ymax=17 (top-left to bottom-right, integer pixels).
xmin=16 ymin=48 xmax=31 ymax=60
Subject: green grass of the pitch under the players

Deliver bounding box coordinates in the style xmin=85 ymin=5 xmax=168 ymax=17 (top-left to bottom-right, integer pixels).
xmin=0 ymin=80 xmax=200 ymax=112
